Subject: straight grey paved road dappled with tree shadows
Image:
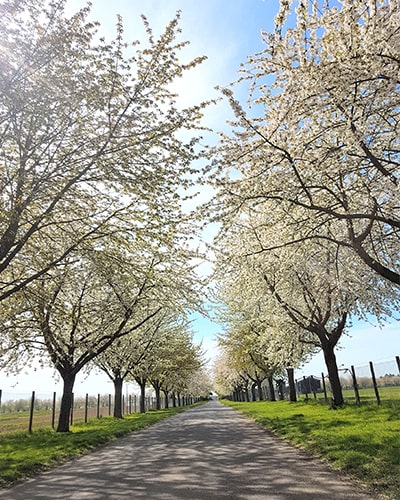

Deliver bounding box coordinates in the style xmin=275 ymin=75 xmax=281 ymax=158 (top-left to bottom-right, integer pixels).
xmin=0 ymin=401 xmax=374 ymax=500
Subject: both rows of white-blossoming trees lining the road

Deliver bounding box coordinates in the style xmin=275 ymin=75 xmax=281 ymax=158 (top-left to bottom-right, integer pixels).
xmin=0 ymin=0 xmax=400 ymax=431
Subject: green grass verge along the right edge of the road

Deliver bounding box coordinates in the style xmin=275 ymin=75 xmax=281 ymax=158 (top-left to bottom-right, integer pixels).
xmin=224 ymin=400 xmax=400 ymax=499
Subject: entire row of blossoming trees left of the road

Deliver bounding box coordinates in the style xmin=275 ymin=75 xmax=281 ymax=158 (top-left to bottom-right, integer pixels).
xmin=0 ymin=0 xmax=211 ymax=432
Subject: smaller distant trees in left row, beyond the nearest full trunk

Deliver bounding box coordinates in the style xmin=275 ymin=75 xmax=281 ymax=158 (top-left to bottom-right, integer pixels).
xmin=94 ymin=317 xmax=211 ymax=417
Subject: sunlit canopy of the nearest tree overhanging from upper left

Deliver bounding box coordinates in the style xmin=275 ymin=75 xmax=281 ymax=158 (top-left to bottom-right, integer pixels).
xmin=0 ymin=0 xmax=208 ymax=300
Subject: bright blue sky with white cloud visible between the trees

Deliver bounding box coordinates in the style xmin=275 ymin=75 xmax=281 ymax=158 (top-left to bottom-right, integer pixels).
xmin=0 ymin=0 xmax=400 ymax=397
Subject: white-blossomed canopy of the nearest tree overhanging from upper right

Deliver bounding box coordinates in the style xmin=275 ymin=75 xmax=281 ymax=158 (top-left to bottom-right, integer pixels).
xmin=212 ymin=0 xmax=400 ymax=285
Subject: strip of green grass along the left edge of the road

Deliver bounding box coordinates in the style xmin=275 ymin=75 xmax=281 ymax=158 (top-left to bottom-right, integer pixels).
xmin=0 ymin=407 xmax=200 ymax=486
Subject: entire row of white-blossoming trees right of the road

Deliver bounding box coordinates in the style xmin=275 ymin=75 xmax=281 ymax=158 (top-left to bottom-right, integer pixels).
xmin=211 ymin=0 xmax=400 ymax=405
